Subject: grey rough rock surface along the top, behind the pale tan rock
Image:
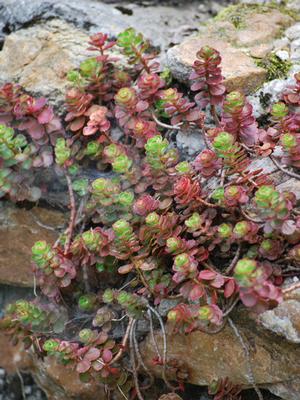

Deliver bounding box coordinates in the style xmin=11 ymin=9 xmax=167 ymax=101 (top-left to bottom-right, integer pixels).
xmin=0 ymin=0 xmax=225 ymax=50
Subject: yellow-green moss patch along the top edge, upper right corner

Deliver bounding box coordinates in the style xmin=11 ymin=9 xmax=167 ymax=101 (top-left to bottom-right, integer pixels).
xmin=214 ymin=2 xmax=300 ymax=29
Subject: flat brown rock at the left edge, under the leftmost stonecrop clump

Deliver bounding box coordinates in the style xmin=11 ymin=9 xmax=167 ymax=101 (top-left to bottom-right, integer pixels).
xmin=0 ymin=201 xmax=65 ymax=286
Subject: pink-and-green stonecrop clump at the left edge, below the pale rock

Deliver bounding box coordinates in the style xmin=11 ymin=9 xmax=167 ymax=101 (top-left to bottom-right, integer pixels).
xmin=0 ymin=83 xmax=64 ymax=201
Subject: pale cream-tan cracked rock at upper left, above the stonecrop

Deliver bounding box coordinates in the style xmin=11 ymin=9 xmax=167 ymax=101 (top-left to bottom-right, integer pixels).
xmin=0 ymin=20 xmax=89 ymax=106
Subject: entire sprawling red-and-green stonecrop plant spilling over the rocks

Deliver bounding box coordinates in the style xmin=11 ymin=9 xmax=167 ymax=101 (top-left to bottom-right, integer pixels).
xmin=0 ymin=29 xmax=300 ymax=400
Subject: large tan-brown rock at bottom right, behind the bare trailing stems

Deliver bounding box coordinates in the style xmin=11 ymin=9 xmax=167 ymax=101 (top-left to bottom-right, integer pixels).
xmin=142 ymin=309 xmax=300 ymax=400
